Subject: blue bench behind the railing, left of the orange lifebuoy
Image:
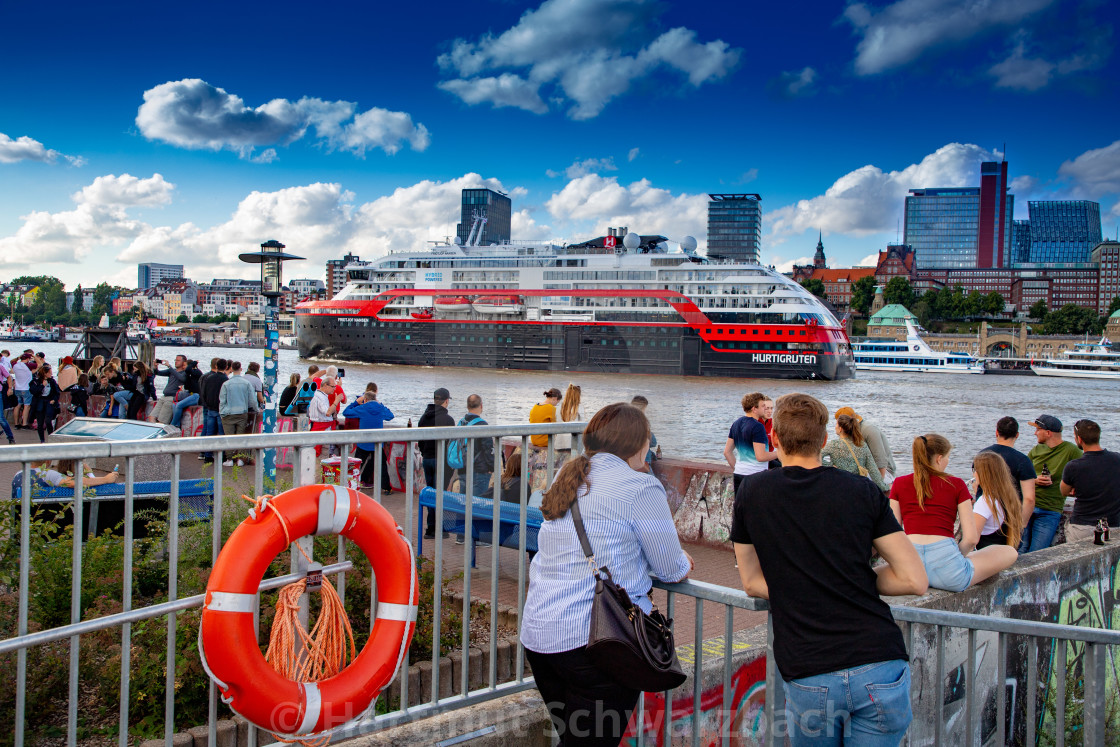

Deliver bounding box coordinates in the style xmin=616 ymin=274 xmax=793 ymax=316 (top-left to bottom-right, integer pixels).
xmin=11 ymin=473 xmax=214 ymax=535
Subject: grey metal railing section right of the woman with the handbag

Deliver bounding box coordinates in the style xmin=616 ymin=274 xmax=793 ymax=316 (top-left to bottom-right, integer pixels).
xmin=635 ymin=580 xmax=1120 ymax=747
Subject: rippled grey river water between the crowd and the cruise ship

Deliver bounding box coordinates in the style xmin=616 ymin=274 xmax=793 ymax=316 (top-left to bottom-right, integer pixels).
xmin=30 ymin=343 xmax=1120 ymax=478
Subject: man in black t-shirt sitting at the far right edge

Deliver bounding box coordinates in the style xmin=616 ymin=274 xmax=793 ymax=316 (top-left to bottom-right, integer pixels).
xmin=1058 ymin=420 xmax=1120 ymax=542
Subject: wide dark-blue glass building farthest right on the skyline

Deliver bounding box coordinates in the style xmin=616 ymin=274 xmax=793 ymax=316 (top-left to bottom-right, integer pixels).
xmin=1027 ymin=199 xmax=1101 ymax=264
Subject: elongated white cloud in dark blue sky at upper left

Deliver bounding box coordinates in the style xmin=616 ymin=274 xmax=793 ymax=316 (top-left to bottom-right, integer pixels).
xmin=136 ymin=78 xmax=430 ymax=162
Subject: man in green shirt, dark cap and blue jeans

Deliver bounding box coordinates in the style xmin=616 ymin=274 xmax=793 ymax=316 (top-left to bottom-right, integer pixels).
xmin=1019 ymin=415 xmax=1081 ymax=552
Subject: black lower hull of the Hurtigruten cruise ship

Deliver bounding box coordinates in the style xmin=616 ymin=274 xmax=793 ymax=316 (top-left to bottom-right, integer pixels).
xmin=297 ymin=315 xmax=855 ymax=381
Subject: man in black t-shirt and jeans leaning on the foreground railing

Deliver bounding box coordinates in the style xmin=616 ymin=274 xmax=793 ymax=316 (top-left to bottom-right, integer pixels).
xmin=731 ymin=394 xmax=927 ymax=746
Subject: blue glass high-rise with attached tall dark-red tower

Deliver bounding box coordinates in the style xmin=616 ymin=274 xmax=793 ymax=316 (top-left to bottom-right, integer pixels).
xmin=903 ymin=161 xmax=1015 ymax=270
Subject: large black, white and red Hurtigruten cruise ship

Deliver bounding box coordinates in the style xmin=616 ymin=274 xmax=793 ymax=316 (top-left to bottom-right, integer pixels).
xmin=296 ymin=227 xmax=855 ymax=380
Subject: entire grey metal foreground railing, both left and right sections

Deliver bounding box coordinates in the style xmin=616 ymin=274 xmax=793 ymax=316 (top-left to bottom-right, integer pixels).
xmin=0 ymin=423 xmax=1120 ymax=746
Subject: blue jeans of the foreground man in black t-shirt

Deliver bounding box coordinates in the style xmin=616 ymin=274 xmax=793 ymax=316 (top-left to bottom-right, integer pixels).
xmin=782 ymin=659 xmax=913 ymax=747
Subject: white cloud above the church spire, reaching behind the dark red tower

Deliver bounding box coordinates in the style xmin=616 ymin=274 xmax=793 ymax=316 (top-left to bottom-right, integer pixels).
xmin=763 ymin=142 xmax=997 ymax=241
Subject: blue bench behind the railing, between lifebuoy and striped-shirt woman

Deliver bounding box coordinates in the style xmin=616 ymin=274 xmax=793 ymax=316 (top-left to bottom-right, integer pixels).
xmin=417 ymin=487 xmax=544 ymax=568
